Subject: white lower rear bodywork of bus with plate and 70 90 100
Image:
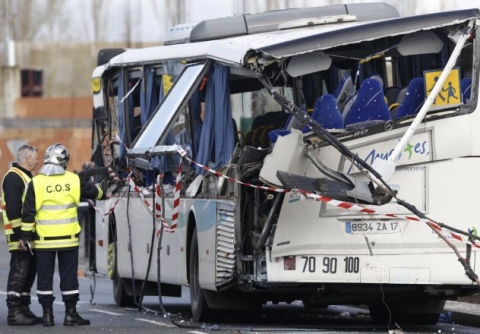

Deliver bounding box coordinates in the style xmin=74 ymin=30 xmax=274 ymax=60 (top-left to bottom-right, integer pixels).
xmin=269 ymin=157 xmax=480 ymax=285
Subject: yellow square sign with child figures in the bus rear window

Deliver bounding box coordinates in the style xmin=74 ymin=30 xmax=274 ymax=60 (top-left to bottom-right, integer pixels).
xmin=423 ymin=67 xmax=463 ymax=109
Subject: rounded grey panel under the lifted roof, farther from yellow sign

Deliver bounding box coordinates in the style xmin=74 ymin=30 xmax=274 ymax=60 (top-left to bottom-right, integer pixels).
xmin=287 ymin=52 xmax=332 ymax=77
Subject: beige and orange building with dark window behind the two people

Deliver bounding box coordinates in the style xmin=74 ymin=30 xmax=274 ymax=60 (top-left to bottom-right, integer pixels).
xmin=0 ymin=42 xmax=130 ymax=177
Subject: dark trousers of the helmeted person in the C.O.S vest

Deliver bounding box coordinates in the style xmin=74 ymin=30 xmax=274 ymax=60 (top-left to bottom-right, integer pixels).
xmin=36 ymin=248 xmax=80 ymax=305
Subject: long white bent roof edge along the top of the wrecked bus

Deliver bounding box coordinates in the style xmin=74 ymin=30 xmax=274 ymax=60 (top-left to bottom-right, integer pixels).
xmin=94 ymin=9 xmax=480 ymax=76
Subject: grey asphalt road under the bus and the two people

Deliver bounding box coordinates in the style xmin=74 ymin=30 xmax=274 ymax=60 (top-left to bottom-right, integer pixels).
xmin=0 ymin=224 xmax=480 ymax=334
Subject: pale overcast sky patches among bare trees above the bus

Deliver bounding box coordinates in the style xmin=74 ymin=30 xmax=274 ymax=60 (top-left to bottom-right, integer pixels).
xmin=60 ymin=0 xmax=480 ymax=43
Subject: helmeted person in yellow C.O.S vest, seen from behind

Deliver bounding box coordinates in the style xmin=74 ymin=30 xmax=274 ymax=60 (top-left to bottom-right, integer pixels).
xmin=20 ymin=144 xmax=105 ymax=326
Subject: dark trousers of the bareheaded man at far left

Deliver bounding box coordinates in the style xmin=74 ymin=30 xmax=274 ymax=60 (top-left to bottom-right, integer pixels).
xmin=7 ymin=251 xmax=37 ymax=307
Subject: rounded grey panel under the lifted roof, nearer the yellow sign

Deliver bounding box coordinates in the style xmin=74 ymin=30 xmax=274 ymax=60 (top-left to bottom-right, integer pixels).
xmin=397 ymin=31 xmax=443 ymax=56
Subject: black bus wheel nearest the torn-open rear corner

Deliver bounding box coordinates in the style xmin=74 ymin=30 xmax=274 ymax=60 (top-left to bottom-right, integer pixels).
xmin=189 ymin=229 xmax=215 ymax=322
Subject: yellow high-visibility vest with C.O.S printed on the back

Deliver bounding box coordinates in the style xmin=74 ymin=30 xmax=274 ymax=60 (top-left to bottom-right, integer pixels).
xmin=32 ymin=172 xmax=81 ymax=249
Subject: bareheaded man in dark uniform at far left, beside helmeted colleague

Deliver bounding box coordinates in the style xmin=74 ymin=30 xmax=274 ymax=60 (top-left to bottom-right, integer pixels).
xmin=2 ymin=145 xmax=42 ymax=326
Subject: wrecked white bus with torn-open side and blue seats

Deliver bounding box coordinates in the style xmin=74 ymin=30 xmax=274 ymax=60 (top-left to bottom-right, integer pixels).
xmin=91 ymin=3 xmax=480 ymax=323
